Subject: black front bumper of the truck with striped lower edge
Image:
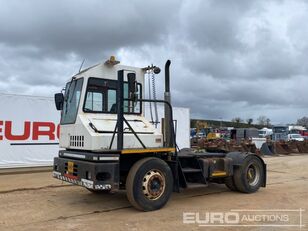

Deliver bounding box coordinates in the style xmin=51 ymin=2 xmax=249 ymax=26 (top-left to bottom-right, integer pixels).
xmin=53 ymin=152 xmax=119 ymax=191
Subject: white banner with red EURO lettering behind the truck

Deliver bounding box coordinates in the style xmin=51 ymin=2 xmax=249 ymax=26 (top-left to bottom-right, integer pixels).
xmin=0 ymin=94 xmax=190 ymax=168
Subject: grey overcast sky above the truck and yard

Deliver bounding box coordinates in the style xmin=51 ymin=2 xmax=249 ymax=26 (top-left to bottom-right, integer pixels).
xmin=0 ymin=0 xmax=308 ymax=124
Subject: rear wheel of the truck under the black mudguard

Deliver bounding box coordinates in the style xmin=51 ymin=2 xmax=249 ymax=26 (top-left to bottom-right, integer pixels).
xmin=233 ymin=155 xmax=265 ymax=193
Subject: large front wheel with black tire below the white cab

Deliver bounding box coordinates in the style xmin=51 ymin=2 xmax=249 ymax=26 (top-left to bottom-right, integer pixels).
xmin=126 ymin=157 xmax=173 ymax=211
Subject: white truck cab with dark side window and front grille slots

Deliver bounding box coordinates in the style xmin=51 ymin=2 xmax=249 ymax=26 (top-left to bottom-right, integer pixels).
xmin=60 ymin=57 xmax=163 ymax=152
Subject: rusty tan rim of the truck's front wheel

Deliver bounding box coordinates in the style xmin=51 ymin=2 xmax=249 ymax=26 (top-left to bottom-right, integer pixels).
xmin=142 ymin=169 xmax=166 ymax=200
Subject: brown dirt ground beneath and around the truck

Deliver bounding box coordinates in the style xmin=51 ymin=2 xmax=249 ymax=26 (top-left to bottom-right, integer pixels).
xmin=0 ymin=154 xmax=308 ymax=231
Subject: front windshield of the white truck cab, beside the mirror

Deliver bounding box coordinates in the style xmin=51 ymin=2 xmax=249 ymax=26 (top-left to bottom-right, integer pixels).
xmin=61 ymin=78 xmax=83 ymax=124
